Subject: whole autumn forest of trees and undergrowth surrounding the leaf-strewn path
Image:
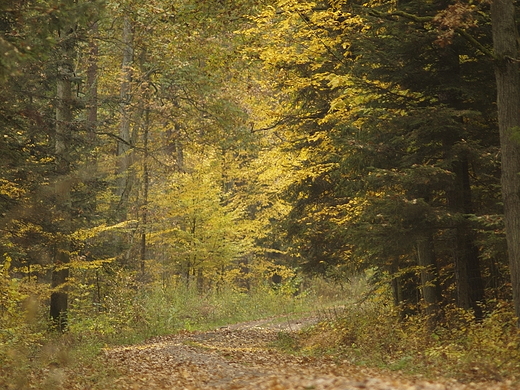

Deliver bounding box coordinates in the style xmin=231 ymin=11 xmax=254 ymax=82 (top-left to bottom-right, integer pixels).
xmin=0 ymin=0 xmax=520 ymax=389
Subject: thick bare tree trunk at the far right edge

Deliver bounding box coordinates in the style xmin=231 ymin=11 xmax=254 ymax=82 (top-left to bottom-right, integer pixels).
xmin=491 ymin=0 xmax=520 ymax=325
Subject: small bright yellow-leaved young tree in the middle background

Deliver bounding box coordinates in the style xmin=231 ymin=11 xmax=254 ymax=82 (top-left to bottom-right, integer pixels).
xmin=151 ymin=155 xmax=251 ymax=284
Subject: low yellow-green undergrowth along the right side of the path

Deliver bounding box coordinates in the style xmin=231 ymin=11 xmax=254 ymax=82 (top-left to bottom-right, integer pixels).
xmin=278 ymin=294 xmax=520 ymax=383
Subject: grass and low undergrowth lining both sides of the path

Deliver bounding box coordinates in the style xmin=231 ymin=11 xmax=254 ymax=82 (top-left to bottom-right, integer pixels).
xmin=7 ymin=272 xmax=520 ymax=390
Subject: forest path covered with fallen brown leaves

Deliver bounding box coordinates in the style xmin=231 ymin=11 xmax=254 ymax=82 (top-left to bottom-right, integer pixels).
xmin=106 ymin=318 xmax=510 ymax=390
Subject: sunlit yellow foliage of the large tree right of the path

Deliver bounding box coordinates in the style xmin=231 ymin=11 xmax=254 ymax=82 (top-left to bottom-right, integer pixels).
xmin=241 ymin=1 xmax=504 ymax=300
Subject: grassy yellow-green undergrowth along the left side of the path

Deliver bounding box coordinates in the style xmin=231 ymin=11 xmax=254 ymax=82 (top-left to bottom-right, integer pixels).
xmin=0 ymin=280 xmax=342 ymax=390
